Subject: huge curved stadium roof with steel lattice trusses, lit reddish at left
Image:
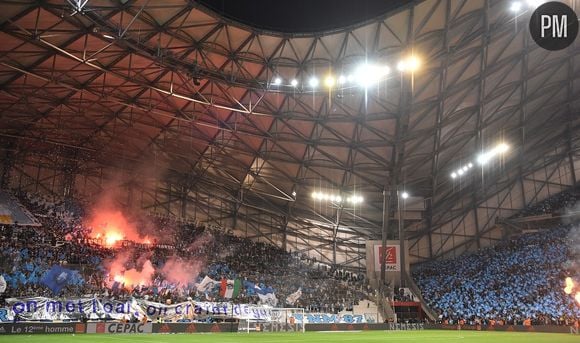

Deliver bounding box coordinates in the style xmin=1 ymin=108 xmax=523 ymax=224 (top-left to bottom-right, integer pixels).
xmin=0 ymin=0 xmax=580 ymax=267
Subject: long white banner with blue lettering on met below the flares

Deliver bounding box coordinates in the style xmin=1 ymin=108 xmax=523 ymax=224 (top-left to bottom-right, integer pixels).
xmin=0 ymin=297 xmax=272 ymax=322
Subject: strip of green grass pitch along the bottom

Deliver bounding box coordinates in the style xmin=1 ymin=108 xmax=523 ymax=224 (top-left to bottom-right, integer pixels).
xmin=0 ymin=330 xmax=580 ymax=343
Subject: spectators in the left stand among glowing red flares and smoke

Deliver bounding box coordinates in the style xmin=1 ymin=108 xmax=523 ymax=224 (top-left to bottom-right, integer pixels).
xmin=0 ymin=193 xmax=367 ymax=313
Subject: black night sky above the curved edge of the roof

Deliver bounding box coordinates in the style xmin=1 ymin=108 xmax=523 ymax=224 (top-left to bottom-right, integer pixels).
xmin=197 ymin=0 xmax=413 ymax=33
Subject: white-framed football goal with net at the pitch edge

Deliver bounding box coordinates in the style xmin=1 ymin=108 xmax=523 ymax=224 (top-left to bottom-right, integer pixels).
xmin=238 ymin=308 xmax=305 ymax=333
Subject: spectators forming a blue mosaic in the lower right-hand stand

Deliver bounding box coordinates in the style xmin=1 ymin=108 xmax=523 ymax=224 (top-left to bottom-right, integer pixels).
xmin=413 ymin=225 xmax=580 ymax=324
